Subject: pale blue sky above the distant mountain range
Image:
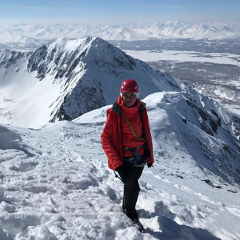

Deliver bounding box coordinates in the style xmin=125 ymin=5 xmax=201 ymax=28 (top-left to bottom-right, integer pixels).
xmin=0 ymin=0 xmax=240 ymax=24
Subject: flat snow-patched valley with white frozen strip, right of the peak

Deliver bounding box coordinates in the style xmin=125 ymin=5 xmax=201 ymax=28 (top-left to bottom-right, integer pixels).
xmin=115 ymin=39 xmax=240 ymax=115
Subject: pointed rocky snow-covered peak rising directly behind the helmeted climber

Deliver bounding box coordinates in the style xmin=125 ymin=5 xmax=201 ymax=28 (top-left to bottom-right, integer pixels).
xmin=0 ymin=37 xmax=183 ymax=128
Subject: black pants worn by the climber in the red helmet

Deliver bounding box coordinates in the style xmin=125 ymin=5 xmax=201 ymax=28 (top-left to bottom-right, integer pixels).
xmin=123 ymin=164 xmax=143 ymax=219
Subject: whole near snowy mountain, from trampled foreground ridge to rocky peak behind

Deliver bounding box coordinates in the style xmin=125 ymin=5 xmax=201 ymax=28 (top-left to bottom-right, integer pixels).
xmin=0 ymin=37 xmax=240 ymax=240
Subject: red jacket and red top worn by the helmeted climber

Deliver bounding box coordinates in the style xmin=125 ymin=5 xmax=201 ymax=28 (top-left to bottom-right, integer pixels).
xmin=101 ymin=96 xmax=154 ymax=170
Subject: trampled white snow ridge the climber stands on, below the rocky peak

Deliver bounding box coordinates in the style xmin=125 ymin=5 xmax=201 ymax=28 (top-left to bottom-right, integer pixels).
xmin=0 ymin=91 xmax=240 ymax=240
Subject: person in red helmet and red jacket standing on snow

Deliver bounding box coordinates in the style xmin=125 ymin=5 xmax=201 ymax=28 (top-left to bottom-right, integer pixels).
xmin=101 ymin=79 xmax=154 ymax=224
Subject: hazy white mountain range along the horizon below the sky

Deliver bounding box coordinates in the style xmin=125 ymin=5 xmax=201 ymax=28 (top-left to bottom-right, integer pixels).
xmin=0 ymin=20 xmax=240 ymax=49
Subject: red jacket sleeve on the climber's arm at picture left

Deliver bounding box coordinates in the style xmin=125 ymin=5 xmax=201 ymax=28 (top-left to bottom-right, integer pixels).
xmin=101 ymin=110 xmax=122 ymax=170
